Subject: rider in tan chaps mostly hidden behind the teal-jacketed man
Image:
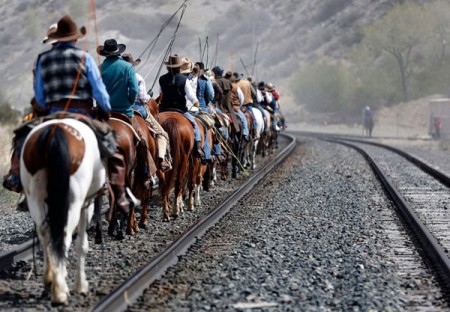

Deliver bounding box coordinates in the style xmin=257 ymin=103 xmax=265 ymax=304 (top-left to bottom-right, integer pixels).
xmin=122 ymin=53 xmax=171 ymax=171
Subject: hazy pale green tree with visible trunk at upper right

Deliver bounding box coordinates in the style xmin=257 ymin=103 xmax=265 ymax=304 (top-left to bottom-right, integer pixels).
xmin=361 ymin=2 xmax=431 ymax=101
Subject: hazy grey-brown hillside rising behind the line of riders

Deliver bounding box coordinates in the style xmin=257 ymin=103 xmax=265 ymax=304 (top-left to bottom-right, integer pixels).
xmin=0 ymin=0 xmax=406 ymax=113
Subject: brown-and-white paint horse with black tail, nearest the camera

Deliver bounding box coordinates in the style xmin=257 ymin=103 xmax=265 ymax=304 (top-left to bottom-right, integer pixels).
xmin=20 ymin=119 xmax=106 ymax=305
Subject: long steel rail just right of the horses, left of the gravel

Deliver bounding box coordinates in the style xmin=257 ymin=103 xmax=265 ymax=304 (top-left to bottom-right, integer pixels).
xmin=91 ymin=134 xmax=296 ymax=311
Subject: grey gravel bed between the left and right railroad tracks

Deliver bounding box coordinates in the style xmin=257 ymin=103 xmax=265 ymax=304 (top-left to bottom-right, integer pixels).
xmin=129 ymin=138 xmax=448 ymax=311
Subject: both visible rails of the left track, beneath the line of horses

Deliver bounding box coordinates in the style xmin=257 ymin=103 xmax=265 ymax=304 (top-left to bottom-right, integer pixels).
xmin=1 ymin=135 xmax=295 ymax=311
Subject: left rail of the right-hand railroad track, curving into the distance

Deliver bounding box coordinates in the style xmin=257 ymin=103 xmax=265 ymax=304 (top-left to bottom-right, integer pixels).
xmin=325 ymin=138 xmax=450 ymax=294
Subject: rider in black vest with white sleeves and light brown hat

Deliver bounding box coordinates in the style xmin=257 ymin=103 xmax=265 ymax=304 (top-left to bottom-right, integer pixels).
xmin=159 ymin=54 xmax=205 ymax=160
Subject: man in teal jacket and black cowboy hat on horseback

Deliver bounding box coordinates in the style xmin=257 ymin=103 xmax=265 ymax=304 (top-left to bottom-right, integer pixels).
xmin=97 ymin=39 xmax=157 ymax=188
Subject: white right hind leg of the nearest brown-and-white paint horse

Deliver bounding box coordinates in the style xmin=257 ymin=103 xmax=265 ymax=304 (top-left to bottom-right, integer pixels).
xmin=75 ymin=203 xmax=94 ymax=294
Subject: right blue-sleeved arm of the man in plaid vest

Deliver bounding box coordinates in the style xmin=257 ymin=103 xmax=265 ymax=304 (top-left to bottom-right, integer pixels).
xmin=85 ymin=53 xmax=111 ymax=113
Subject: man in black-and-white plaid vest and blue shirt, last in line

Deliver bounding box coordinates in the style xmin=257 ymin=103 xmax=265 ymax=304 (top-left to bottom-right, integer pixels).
xmin=3 ymin=15 xmax=111 ymax=193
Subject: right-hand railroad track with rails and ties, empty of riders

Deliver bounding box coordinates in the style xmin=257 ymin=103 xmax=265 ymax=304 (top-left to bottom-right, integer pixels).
xmin=303 ymin=133 xmax=450 ymax=300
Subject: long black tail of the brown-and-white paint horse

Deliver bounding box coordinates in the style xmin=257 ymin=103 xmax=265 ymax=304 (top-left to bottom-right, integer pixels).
xmin=39 ymin=125 xmax=70 ymax=259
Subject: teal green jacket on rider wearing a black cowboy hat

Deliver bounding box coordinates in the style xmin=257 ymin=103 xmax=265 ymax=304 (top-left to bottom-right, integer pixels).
xmin=100 ymin=56 xmax=139 ymax=117
